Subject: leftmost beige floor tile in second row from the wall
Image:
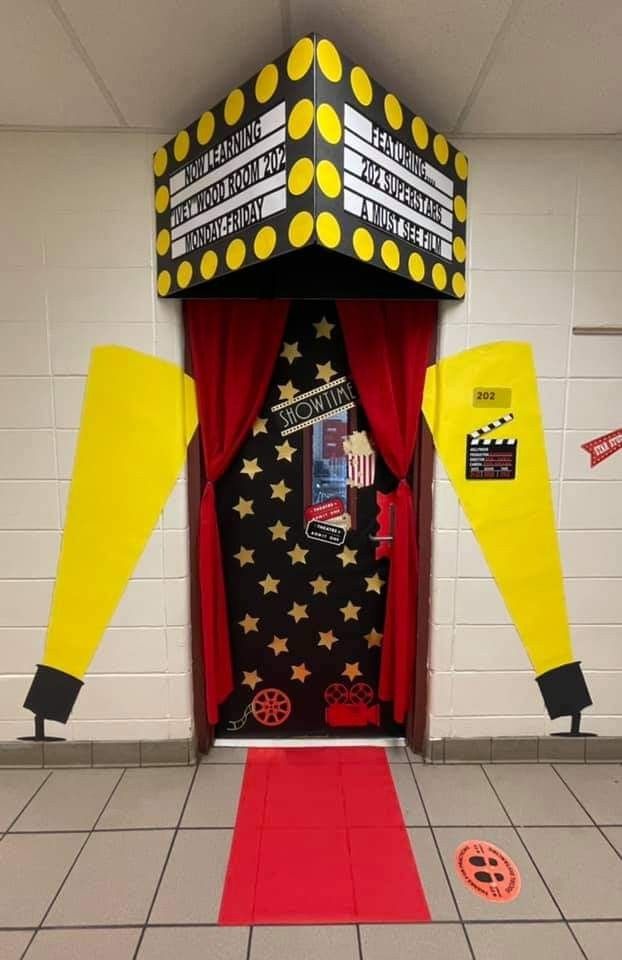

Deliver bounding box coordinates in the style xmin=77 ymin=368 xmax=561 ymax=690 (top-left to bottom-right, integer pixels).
xmin=0 ymin=833 xmax=84 ymax=927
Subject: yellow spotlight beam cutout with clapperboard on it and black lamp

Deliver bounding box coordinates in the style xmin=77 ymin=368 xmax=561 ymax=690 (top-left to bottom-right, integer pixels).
xmin=423 ymin=342 xmax=592 ymax=732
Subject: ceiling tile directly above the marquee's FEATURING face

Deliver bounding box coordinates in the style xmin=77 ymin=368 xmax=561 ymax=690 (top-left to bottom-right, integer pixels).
xmin=290 ymin=0 xmax=510 ymax=131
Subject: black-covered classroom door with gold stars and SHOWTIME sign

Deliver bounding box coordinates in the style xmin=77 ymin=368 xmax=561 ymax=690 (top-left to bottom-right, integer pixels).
xmin=217 ymin=301 xmax=403 ymax=738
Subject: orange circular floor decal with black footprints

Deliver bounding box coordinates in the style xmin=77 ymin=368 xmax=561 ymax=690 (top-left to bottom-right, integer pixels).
xmin=456 ymin=840 xmax=521 ymax=903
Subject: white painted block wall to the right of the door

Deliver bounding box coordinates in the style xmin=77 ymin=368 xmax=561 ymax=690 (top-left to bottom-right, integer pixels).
xmin=429 ymin=140 xmax=622 ymax=737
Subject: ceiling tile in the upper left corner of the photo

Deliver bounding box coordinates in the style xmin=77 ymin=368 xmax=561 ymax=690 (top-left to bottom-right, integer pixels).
xmin=0 ymin=0 xmax=119 ymax=127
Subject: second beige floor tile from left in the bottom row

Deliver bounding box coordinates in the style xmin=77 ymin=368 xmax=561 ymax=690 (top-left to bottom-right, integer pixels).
xmin=25 ymin=929 xmax=140 ymax=960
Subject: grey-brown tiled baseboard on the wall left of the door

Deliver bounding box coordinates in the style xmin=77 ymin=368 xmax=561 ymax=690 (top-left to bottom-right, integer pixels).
xmin=0 ymin=739 xmax=197 ymax=768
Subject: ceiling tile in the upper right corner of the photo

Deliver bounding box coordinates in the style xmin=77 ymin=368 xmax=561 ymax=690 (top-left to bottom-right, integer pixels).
xmin=463 ymin=0 xmax=622 ymax=134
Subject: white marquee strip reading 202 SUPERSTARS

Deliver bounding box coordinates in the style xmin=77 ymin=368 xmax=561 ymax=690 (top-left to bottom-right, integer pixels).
xmin=343 ymin=156 xmax=453 ymax=240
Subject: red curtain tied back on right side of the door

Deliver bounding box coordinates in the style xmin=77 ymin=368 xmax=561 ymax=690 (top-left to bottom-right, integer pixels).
xmin=339 ymin=300 xmax=437 ymax=723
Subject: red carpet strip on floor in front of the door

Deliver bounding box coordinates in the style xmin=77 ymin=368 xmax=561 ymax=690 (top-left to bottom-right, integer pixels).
xmin=219 ymin=747 xmax=430 ymax=925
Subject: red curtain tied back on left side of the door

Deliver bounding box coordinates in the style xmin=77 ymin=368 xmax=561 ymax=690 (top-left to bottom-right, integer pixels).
xmin=184 ymin=300 xmax=289 ymax=723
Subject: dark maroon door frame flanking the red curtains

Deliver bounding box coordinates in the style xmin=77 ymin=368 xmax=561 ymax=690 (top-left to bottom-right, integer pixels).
xmin=184 ymin=308 xmax=438 ymax=753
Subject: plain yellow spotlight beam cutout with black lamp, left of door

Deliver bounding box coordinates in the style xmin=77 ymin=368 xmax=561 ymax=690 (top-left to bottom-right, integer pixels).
xmin=24 ymin=346 xmax=197 ymax=732
